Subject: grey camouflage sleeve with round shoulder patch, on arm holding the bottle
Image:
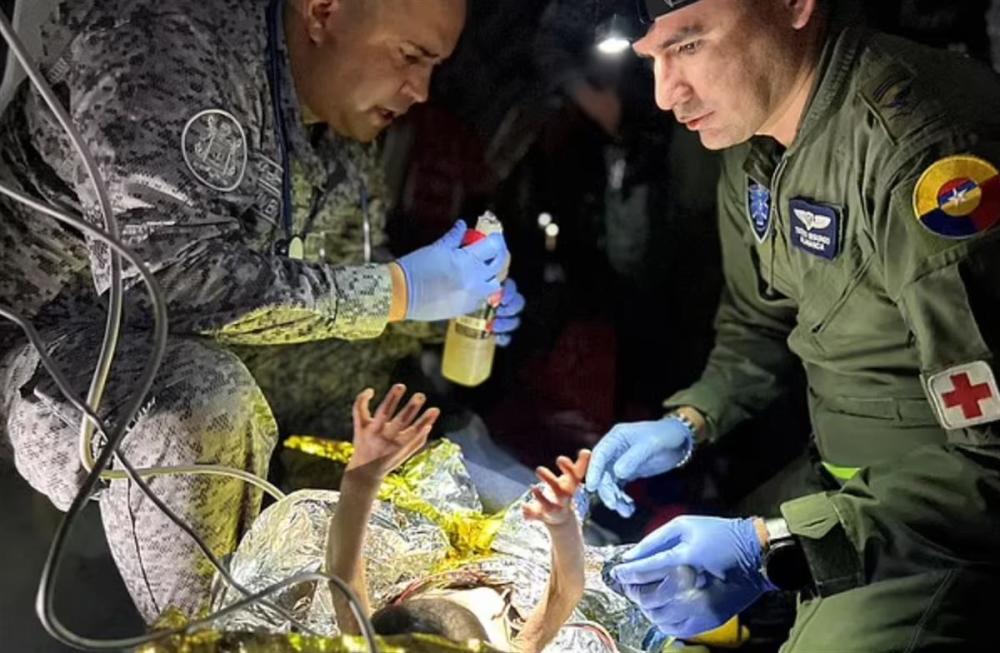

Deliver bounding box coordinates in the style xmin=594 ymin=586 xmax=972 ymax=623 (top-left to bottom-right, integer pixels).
xmin=46 ymin=14 xmax=391 ymax=344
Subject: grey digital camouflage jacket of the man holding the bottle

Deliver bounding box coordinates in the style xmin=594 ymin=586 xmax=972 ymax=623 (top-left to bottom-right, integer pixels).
xmin=0 ymin=0 xmax=391 ymax=344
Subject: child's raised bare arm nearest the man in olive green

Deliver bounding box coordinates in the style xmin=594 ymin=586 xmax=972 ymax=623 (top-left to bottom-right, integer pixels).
xmin=514 ymin=450 xmax=590 ymax=653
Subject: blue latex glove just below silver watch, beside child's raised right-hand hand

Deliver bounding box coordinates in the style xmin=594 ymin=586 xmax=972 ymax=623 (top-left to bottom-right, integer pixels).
xmin=587 ymin=417 xmax=694 ymax=517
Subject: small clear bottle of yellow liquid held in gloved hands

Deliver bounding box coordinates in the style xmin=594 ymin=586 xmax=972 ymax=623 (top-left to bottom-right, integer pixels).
xmin=441 ymin=211 xmax=510 ymax=387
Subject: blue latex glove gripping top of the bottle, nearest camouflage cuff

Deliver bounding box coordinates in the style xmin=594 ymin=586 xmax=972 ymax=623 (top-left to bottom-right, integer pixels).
xmin=397 ymin=220 xmax=509 ymax=322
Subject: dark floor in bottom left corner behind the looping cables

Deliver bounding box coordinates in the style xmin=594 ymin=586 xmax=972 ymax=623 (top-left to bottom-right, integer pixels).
xmin=0 ymin=467 xmax=143 ymax=653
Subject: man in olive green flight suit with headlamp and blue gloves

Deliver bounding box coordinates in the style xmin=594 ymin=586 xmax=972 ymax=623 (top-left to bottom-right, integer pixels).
xmin=587 ymin=0 xmax=1000 ymax=651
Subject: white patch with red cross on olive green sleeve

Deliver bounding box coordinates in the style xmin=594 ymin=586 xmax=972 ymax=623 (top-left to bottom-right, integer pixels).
xmin=926 ymin=361 xmax=1000 ymax=430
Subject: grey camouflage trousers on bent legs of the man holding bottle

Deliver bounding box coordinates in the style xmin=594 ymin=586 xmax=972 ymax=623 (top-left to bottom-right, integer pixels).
xmin=0 ymin=321 xmax=278 ymax=621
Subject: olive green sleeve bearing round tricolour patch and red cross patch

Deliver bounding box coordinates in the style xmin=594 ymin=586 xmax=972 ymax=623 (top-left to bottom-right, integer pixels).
xmin=782 ymin=142 xmax=1000 ymax=586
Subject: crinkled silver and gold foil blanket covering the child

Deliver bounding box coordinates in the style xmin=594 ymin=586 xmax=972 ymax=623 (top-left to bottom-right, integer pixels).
xmin=207 ymin=439 xmax=651 ymax=653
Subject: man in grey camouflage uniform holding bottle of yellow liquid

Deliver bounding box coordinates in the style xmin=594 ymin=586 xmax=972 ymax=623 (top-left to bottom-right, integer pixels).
xmin=0 ymin=0 xmax=520 ymax=620
